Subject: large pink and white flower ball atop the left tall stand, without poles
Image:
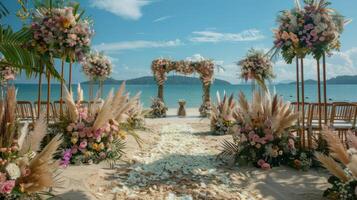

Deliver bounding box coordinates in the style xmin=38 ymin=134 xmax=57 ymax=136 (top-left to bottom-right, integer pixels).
xmin=30 ymin=4 xmax=94 ymax=61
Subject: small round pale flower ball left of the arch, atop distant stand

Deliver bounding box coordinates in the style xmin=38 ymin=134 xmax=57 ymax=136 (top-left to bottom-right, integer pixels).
xmin=82 ymin=53 xmax=112 ymax=80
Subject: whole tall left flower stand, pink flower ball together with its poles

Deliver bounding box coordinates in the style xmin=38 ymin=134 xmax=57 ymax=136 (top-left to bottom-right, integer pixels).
xmin=31 ymin=4 xmax=93 ymax=119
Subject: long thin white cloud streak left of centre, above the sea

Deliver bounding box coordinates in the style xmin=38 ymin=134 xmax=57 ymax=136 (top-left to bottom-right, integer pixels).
xmin=94 ymin=39 xmax=183 ymax=52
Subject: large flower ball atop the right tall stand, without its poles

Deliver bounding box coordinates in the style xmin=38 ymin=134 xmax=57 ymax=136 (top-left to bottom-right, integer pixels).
xmin=274 ymin=0 xmax=348 ymax=63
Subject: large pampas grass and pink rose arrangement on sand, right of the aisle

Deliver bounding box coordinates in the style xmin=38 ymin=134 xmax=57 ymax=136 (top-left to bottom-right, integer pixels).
xmin=220 ymin=92 xmax=298 ymax=169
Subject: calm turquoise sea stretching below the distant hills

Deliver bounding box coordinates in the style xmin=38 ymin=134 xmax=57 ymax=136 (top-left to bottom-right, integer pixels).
xmin=12 ymin=84 xmax=357 ymax=108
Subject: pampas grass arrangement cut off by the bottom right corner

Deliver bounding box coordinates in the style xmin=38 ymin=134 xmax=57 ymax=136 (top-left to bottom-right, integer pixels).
xmin=315 ymin=129 xmax=357 ymax=200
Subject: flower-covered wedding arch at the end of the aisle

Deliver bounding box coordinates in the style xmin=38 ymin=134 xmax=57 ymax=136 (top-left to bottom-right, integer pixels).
xmin=151 ymin=59 xmax=214 ymax=117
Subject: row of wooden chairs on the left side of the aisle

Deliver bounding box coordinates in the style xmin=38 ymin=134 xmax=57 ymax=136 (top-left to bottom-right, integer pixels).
xmin=16 ymin=101 xmax=100 ymax=122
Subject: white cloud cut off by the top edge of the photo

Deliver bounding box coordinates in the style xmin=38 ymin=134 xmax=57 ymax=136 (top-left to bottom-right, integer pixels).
xmin=91 ymin=0 xmax=150 ymax=20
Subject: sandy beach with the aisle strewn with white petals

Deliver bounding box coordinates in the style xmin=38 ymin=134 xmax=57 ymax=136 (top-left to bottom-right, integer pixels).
xmin=52 ymin=109 xmax=328 ymax=200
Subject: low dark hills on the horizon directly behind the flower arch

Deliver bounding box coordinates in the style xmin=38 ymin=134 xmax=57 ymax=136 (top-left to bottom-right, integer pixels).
xmin=82 ymin=76 xmax=231 ymax=85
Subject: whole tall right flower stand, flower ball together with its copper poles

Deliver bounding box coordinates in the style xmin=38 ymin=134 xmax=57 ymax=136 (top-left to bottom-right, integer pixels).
xmin=271 ymin=0 xmax=348 ymax=148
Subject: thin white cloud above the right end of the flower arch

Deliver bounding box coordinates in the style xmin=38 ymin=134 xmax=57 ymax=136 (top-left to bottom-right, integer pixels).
xmin=190 ymin=29 xmax=264 ymax=43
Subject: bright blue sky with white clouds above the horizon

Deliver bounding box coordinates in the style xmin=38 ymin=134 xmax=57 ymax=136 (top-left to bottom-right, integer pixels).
xmin=1 ymin=0 xmax=357 ymax=83
